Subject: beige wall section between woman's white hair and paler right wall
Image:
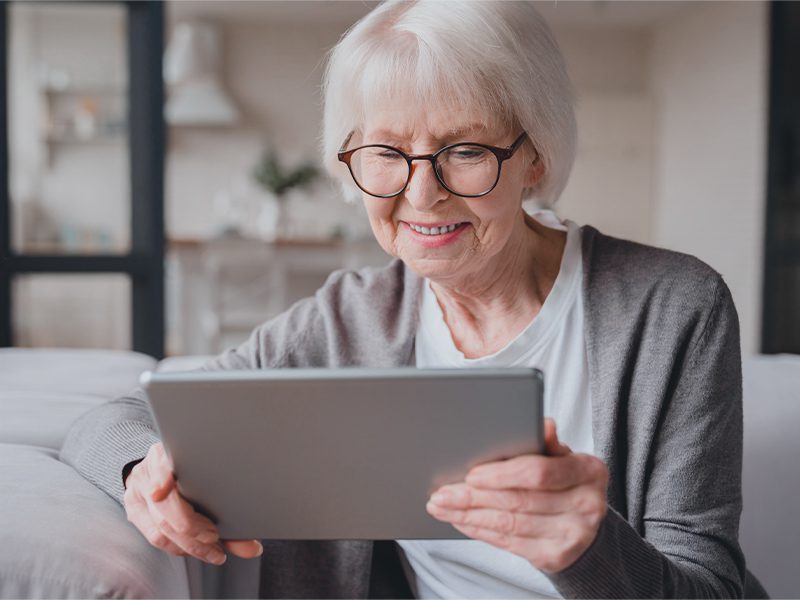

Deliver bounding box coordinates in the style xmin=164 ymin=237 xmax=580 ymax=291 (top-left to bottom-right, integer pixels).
xmin=555 ymin=26 xmax=653 ymax=243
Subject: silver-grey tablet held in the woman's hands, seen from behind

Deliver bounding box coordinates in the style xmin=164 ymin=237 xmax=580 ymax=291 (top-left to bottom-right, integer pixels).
xmin=142 ymin=368 xmax=544 ymax=540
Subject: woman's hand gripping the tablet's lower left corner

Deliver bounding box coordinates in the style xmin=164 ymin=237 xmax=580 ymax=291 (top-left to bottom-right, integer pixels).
xmin=123 ymin=442 xmax=263 ymax=565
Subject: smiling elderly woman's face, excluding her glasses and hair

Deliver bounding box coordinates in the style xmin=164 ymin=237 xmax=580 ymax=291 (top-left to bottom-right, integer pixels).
xmin=360 ymin=106 xmax=541 ymax=281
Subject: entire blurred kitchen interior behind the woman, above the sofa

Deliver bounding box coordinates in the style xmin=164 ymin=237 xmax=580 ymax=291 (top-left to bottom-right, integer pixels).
xmin=0 ymin=0 xmax=800 ymax=357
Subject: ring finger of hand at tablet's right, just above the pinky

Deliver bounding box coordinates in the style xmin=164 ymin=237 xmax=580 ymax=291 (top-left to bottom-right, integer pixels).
xmin=426 ymin=504 xmax=568 ymax=540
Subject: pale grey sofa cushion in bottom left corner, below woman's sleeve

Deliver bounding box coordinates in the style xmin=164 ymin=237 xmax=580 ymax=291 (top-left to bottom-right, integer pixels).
xmin=0 ymin=444 xmax=189 ymax=598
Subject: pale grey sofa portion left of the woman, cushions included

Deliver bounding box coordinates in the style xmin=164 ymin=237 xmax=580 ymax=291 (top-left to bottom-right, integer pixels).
xmin=0 ymin=348 xmax=260 ymax=598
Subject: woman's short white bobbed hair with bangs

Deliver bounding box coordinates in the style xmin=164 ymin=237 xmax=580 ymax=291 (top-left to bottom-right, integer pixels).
xmin=322 ymin=0 xmax=577 ymax=206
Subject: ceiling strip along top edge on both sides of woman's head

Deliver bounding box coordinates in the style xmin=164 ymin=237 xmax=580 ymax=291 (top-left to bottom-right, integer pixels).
xmin=168 ymin=0 xmax=692 ymax=28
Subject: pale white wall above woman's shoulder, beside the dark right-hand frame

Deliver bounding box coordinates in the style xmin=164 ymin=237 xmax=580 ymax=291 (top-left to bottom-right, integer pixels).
xmin=650 ymin=2 xmax=768 ymax=353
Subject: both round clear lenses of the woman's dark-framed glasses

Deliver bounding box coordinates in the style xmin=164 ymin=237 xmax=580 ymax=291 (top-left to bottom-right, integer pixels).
xmin=350 ymin=144 xmax=500 ymax=196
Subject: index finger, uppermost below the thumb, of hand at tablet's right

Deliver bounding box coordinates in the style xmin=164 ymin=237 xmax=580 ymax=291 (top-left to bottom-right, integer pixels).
xmin=465 ymin=454 xmax=605 ymax=491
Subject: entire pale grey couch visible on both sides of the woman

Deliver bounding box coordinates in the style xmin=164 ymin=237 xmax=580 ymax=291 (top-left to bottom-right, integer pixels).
xmin=0 ymin=349 xmax=800 ymax=598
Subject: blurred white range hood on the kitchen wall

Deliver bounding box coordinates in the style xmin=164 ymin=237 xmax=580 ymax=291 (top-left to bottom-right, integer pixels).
xmin=164 ymin=21 xmax=239 ymax=125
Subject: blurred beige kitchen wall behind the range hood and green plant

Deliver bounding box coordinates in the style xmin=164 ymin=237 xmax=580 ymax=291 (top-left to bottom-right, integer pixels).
xmin=166 ymin=21 xmax=363 ymax=238
